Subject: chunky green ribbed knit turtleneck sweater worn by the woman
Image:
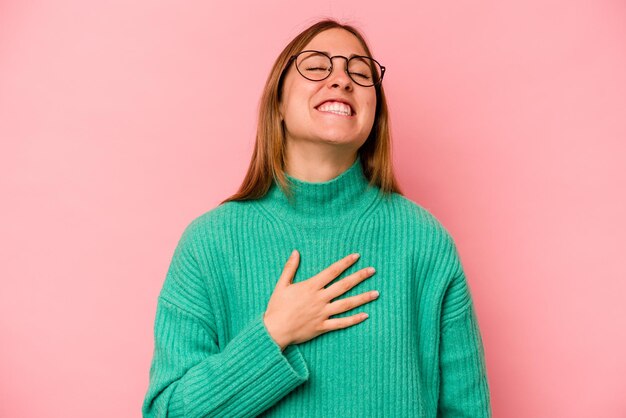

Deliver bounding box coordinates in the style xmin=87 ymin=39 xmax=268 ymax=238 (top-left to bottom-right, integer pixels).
xmin=142 ymin=158 xmax=491 ymax=418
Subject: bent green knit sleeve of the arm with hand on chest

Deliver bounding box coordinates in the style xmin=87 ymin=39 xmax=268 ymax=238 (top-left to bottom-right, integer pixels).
xmin=142 ymin=223 xmax=309 ymax=417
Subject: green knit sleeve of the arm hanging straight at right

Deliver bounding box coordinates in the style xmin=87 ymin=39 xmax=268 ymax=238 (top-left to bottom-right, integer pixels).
xmin=437 ymin=231 xmax=492 ymax=418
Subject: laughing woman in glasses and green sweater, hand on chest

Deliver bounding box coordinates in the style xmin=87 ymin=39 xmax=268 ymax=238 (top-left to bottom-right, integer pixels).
xmin=143 ymin=20 xmax=491 ymax=417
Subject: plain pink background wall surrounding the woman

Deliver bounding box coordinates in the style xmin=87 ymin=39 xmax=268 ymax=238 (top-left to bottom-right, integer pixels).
xmin=0 ymin=0 xmax=626 ymax=418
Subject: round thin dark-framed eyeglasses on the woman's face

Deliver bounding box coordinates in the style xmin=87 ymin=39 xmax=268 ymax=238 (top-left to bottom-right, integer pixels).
xmin=288 ymin=50 xmax=385 ymax=87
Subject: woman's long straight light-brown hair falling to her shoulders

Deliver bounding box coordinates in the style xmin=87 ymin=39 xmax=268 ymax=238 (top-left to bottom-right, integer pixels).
xmin=220 ymin=18 xmax=402 ymax=204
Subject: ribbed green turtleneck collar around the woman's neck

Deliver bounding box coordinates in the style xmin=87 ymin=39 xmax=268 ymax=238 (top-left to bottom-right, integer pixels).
xmin=261 ymin=156 xmax=380 ymax=227
